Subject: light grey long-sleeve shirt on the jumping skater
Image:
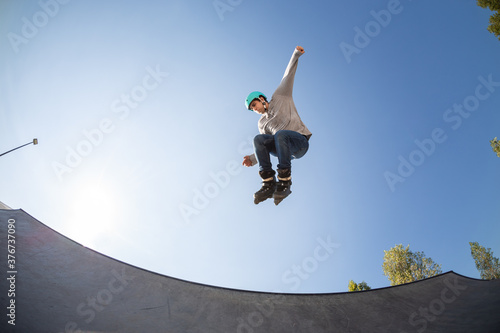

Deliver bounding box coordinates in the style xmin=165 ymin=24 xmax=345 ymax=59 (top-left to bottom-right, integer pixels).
xmin=250 ymin=49 xmax=312 ymax=165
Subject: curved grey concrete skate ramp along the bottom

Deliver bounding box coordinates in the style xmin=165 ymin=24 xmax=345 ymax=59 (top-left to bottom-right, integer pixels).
xmin=0 ymin=209 xmax=500 ymax=333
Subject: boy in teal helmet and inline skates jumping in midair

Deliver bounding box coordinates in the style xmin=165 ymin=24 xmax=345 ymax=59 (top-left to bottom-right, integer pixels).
xmin=243 ymin=46 xmax=312 ymax=205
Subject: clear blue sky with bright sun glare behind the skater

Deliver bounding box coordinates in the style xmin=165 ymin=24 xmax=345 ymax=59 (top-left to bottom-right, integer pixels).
xmin=0 ymin=0 xmax=500 ymax=293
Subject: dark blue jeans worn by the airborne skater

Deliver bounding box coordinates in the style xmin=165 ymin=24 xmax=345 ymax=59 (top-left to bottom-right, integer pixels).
xmin=253 ymin=130 xmax=309 ymax=171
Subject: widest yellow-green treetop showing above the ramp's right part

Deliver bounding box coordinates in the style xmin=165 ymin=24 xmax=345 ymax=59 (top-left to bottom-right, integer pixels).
xmin=382 ymin=244 xmax=442 ymax=286
